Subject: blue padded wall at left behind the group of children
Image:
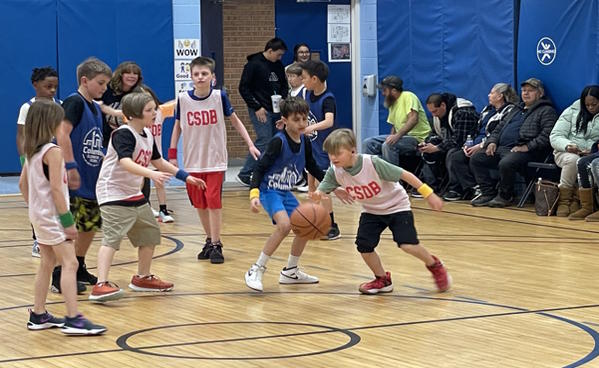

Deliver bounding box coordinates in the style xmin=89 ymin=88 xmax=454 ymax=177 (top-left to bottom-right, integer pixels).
xmin=0 ymin=0 xmax=174 ymax=173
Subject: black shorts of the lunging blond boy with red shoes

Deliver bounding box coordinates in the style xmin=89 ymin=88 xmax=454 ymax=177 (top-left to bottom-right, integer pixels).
xmin=356 ymin=211 xmax=420 ymax=253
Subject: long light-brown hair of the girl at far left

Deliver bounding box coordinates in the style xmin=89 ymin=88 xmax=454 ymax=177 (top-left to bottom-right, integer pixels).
xmin=23 ymin=99 xmax=64 ymax=160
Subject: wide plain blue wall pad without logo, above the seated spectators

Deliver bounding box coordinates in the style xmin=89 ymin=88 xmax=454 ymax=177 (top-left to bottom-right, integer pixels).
xmin=377 ymin=0 xmax=514 ymax=133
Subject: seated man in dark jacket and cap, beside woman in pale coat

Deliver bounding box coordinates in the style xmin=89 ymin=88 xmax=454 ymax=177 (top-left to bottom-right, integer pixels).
xmin=470 ymin=78 xmax=557 ymax=207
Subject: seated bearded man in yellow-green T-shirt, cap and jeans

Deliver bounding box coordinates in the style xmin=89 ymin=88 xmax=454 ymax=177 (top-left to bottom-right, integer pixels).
xmin=362 ymin=75 xmax=431 ymax=169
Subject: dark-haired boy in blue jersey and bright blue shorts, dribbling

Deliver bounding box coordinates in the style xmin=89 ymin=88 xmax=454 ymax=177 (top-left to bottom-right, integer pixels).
xmin=245 ymin=97 xmax=330 ymax=291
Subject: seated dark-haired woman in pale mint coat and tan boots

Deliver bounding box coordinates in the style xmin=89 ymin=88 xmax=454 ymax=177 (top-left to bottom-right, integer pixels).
xmin=564 ymin=85 xmax=599 ymax=221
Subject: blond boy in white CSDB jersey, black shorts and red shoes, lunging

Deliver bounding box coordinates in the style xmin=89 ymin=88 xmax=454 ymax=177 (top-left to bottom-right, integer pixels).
xmin=311 ymin=129 xmax=451 ymax=294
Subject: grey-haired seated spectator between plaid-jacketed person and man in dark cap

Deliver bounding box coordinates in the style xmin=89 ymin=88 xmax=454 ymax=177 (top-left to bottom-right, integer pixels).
xmin=443 ymin=83 xmax=520 ymax=201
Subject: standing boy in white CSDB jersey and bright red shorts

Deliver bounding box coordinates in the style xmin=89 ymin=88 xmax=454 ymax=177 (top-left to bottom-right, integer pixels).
xmin=168 ymin=56 xmax=260 ymax=263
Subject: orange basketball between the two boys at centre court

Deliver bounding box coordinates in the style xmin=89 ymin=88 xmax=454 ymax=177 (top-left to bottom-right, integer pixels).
xmin=290 ymin=202 xmax=331 ymax=240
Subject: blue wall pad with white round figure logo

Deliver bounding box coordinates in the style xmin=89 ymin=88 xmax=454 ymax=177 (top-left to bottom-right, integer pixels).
xmin=518 ymin=0 xmax=599 ymax=111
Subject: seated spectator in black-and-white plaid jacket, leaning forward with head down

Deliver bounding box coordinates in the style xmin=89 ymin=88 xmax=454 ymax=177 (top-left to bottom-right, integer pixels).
xmin=420 ymin=93 xmax=478 ymax=193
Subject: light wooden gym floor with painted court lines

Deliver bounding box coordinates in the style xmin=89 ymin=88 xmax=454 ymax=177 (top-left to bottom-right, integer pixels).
xmin=0 ymin=188 xmax=599 ymax=368
